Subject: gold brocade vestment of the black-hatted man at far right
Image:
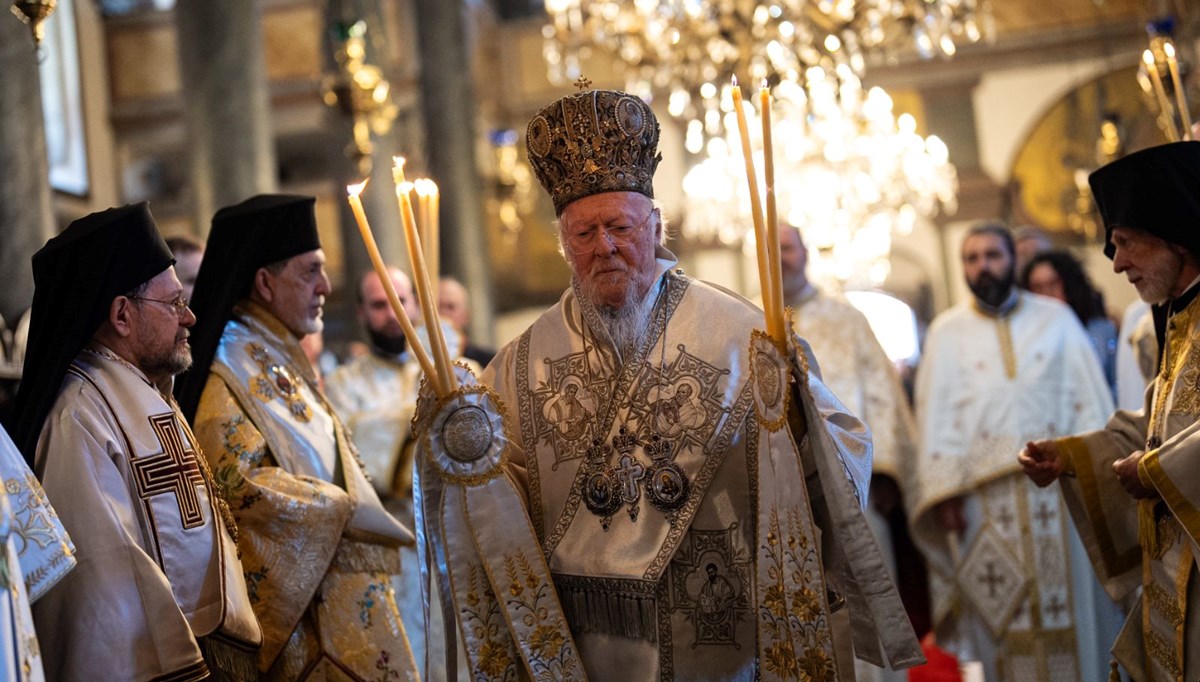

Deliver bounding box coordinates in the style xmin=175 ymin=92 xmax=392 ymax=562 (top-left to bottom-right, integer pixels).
xmin=1058 ymin=288 xmax=1200 ymax=682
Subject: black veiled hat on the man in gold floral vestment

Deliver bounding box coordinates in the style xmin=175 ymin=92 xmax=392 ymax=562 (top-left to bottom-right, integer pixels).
xmin=175 ymin=189 xmax=320 ymax=421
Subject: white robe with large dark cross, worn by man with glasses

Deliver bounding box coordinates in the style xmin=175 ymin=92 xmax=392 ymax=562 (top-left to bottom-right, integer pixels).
xmin=34 ymin=343 xmax=262 ymax=681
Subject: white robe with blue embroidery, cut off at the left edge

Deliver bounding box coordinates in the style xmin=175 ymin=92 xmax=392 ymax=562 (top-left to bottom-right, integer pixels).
xmin=0 ymin=427 xmax=76 ymax=682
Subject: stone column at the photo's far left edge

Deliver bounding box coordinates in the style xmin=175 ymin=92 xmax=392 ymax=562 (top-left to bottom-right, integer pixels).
xmin=0 ymin=18 xmax=55 ymax=327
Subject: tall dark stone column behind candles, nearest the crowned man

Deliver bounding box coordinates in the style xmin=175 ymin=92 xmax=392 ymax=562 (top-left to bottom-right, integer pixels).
xmin=415 ymin=0 xmax=494 ymax=343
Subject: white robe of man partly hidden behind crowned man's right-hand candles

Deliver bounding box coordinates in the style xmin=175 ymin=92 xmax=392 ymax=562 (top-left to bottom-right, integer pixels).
xmin=787 ymin=286 xmax=917 ymax=682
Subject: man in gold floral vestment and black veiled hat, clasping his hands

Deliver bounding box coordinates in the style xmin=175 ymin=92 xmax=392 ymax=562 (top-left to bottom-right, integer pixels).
xmin=179 ymin=195 xmax=418 ymax=681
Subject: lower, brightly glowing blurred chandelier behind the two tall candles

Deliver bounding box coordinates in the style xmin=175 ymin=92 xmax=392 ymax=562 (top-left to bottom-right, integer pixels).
xmin=680 ymin=67 xmax=958 ymax=288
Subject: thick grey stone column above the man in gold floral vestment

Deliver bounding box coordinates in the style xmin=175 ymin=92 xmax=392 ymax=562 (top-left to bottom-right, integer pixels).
xmin=175 ymin=0 xmax=276 ymax=234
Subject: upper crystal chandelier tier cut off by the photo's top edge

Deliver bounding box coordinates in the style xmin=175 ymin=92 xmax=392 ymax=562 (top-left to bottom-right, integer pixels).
xmin=542 ymin=0 xmax=994 ymax=136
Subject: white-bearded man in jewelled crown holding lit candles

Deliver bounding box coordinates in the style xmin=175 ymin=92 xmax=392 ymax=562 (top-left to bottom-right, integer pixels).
xmin=418 ymin=85 xmax=920 ymax=681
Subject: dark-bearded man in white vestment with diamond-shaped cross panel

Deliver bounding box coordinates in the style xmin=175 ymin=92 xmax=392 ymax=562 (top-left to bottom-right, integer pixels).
xmin=905 ymin=223 xmax=1120 ymax=682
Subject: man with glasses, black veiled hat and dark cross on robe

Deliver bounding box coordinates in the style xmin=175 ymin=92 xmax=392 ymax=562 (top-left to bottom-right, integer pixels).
xmin=14 ymin=203 xmax=262 ymax=680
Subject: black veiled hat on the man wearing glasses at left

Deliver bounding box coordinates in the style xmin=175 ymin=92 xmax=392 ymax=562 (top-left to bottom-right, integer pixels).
xmin=10 ymin=202 xmax=175 ymax=466
